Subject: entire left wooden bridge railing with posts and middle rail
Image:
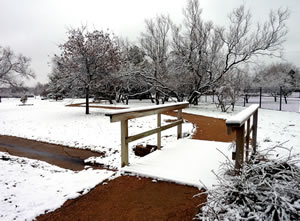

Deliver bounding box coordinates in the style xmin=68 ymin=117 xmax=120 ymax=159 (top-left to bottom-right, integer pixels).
xmin=105 ymin=102 xmax=189 ymax=167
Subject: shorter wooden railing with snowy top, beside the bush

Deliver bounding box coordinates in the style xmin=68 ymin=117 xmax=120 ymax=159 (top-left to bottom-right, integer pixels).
xmin=226 ymin=104 xmax=259 ymax=170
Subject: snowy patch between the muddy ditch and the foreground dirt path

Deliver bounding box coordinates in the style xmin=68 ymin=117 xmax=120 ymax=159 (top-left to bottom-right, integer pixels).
xmin=0 ymin=152 xmax=113 ymax=221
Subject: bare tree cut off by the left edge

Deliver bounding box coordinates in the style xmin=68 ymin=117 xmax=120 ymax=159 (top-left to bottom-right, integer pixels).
xmin=0 ymin=46 xmax=35 ymax=87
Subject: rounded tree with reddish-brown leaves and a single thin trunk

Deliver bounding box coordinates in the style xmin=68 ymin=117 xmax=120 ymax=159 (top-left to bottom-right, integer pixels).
xmin=56 ymin=27 xmax=120 ymax=114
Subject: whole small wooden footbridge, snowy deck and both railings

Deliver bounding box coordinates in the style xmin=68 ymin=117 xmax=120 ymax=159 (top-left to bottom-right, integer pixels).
xmin=106 ymin=102 xmax=258 ymax=186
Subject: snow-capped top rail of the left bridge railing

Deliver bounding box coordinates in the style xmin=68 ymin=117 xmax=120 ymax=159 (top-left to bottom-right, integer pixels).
xmin=105 ymin=102 xmax=189 ymax=123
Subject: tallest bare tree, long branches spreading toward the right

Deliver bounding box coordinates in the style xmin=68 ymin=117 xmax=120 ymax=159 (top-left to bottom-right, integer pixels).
xmin=172 ymin=0 xmax=289 ymax=103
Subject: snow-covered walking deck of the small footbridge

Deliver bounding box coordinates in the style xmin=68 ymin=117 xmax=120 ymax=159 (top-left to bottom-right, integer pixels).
xmin=122 ymin=139 xmax=232 ymax=188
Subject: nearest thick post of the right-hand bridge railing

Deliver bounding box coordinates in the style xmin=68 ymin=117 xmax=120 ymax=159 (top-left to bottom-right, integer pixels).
xmin=235 ymin=124 xmax=245 ymax=171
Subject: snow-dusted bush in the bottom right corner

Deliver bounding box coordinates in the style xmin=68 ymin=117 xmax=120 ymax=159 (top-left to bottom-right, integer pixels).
xmin=196 ymin=146 xmax=300 ymax=220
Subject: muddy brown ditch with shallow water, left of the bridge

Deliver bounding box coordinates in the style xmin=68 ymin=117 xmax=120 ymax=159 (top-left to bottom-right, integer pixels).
xmin=0 ymin=135 xmax=102 ymax=170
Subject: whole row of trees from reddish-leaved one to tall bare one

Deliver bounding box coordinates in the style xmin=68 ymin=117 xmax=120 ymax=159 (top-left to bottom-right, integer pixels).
xmin=1 ymin=0 xmax=289 ymax=114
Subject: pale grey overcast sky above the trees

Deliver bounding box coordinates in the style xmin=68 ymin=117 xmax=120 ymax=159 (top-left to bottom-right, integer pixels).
xmin=0 ymin=0 xmax=300 ymax=85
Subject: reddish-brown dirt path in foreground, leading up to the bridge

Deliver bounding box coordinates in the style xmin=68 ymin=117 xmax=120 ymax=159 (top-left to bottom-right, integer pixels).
xmin=37 ymin=176 xmax=206 ymax=221
